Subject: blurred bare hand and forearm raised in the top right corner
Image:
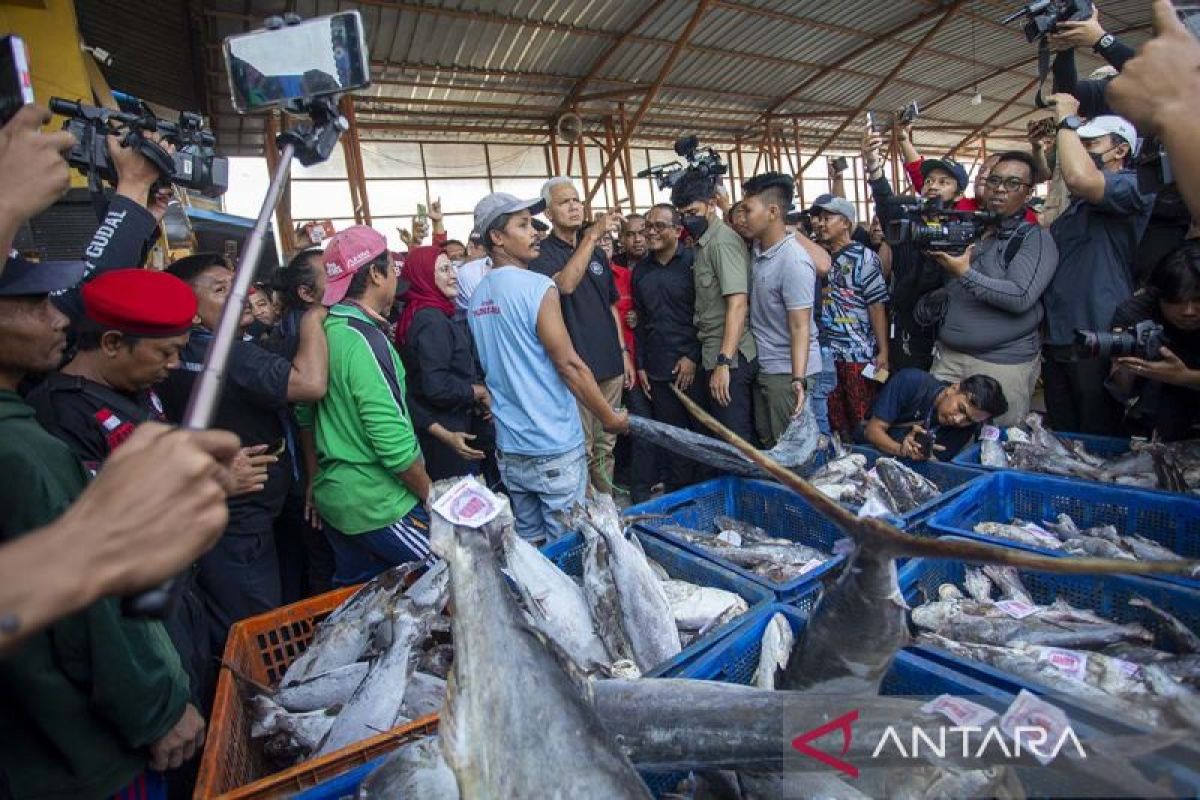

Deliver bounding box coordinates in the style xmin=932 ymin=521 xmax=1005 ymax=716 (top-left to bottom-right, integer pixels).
xmin=1106 ymin=0 xmax=1200 ymax=218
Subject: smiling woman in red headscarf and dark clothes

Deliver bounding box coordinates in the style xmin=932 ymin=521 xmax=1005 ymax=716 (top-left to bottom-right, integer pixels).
xmin=396 ymin=247 xmax=492 ymax=481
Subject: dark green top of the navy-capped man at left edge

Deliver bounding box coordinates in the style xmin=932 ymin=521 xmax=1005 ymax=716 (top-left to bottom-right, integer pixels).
xmin=0 ymin=391 xmax=188 ymax=800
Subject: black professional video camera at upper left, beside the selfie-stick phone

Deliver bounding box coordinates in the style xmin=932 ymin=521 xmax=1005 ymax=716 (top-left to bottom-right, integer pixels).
xmin=50 ymin=97 xmax=229 ymax=197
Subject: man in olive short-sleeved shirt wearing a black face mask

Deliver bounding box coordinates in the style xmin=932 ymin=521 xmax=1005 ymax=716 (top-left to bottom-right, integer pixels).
xmin=671 ymin=170 xmax=758 ymax=441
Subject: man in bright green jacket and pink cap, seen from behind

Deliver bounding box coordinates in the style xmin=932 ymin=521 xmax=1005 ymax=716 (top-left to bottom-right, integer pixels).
xmin=298 ymin=225 xmax=434 ymax=585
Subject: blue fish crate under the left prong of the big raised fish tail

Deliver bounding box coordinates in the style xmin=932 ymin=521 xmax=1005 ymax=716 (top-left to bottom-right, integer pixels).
xmin=625 ymin=476 xmax=859 ymax=599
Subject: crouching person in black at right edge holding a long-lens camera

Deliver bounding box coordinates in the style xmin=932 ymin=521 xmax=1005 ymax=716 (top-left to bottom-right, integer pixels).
xmin=1110 ymin=241 xmax=1200 ymax=441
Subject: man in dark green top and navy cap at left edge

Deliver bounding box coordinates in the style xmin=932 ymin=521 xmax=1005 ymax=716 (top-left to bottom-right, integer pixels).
xmin=0 ymin=259 xmax=204 ymax=800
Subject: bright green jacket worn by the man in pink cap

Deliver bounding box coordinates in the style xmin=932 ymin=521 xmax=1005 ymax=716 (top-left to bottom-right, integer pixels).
xmin=296 ymin=305 xmax=421 ymax=535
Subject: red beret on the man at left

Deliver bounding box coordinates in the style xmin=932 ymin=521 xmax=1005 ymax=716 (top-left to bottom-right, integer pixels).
xmin=83 ymin=270 xmax=196 ymax=336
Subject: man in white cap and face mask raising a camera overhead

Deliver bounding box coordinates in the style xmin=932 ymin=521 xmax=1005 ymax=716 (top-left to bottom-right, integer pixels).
xmin=1042 ymin=95 xmax=1154 ymax=435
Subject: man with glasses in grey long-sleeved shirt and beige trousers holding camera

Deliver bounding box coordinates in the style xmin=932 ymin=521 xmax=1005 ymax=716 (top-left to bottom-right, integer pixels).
xmin=932 ymin=152 xmax=1058 ymax=426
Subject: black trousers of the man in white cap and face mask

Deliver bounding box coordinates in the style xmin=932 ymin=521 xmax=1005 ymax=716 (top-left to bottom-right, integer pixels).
xmin=1042 ymin=347 xmax=1121 ymax=437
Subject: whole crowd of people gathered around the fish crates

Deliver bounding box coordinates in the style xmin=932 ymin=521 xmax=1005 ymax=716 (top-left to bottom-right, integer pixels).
xmin=0 ymin=0 xmax=1200 ymax=798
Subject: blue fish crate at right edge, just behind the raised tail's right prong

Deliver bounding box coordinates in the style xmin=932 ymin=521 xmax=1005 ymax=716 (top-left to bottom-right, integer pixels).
xmin=929 ymin=471 xmax=1200 ymax=587
